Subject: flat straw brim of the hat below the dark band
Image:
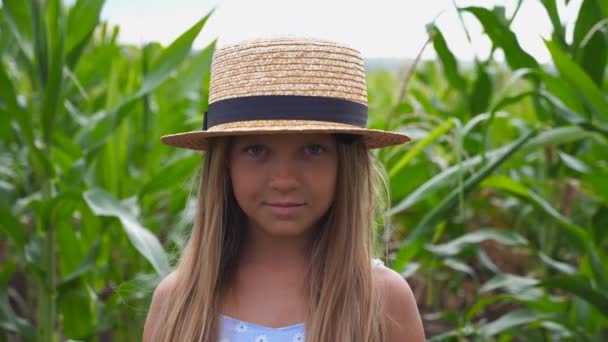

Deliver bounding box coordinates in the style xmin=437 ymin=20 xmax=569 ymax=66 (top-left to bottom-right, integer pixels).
xmin=160 ymin=120 xmax=411 ymax=151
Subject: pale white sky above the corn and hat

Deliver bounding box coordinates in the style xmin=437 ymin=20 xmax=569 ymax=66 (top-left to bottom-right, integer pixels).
xmin=92 ymin=0 xmax=581 ymax=62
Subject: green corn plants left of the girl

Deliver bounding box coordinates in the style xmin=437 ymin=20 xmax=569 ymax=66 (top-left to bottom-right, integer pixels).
xmin=0 ymin=0 xmax=214 ymax=341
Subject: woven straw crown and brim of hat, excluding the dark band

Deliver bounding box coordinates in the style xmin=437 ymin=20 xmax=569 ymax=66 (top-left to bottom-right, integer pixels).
xmin=161 ymin=37 xmax=410 ymax=150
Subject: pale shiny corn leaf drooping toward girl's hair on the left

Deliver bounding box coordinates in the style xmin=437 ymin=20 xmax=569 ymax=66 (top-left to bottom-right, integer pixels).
xmin=83 ymin=188 xmax=169 ymax=276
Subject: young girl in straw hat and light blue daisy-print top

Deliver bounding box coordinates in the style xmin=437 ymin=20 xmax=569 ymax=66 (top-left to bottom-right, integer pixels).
xmin=143 ymin=37 xmax=424 ymax=342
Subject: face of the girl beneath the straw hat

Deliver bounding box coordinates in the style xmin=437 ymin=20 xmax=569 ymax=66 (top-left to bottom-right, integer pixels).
xmin=229 ymin=134 xmax=338 ymax=237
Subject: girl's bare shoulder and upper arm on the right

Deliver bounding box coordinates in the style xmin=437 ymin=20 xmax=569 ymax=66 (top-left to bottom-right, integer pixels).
xmin=374 ymin=266 xmax=425 ymax=342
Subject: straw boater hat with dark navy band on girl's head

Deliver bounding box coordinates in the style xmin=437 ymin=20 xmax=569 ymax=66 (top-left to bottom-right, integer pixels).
xmin=161 ymin=36 xmax=410 ymax=150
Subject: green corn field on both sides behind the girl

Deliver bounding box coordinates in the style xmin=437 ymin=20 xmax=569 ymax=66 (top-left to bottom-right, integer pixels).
xmin=0 ymin=0 xmax=608 ymax=342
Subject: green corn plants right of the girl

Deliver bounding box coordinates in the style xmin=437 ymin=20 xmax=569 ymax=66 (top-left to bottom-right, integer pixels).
xmin=370 ymin=0 xmax=608 ymax=341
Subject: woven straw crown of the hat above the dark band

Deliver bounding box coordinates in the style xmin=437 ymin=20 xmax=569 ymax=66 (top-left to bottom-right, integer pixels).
xmin=209 ymin=38 xmax=367 ymax=104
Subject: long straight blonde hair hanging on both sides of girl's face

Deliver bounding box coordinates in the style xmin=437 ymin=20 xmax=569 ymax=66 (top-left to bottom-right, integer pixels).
xmin=152 ymin=138 xmax=384 ymax=342
